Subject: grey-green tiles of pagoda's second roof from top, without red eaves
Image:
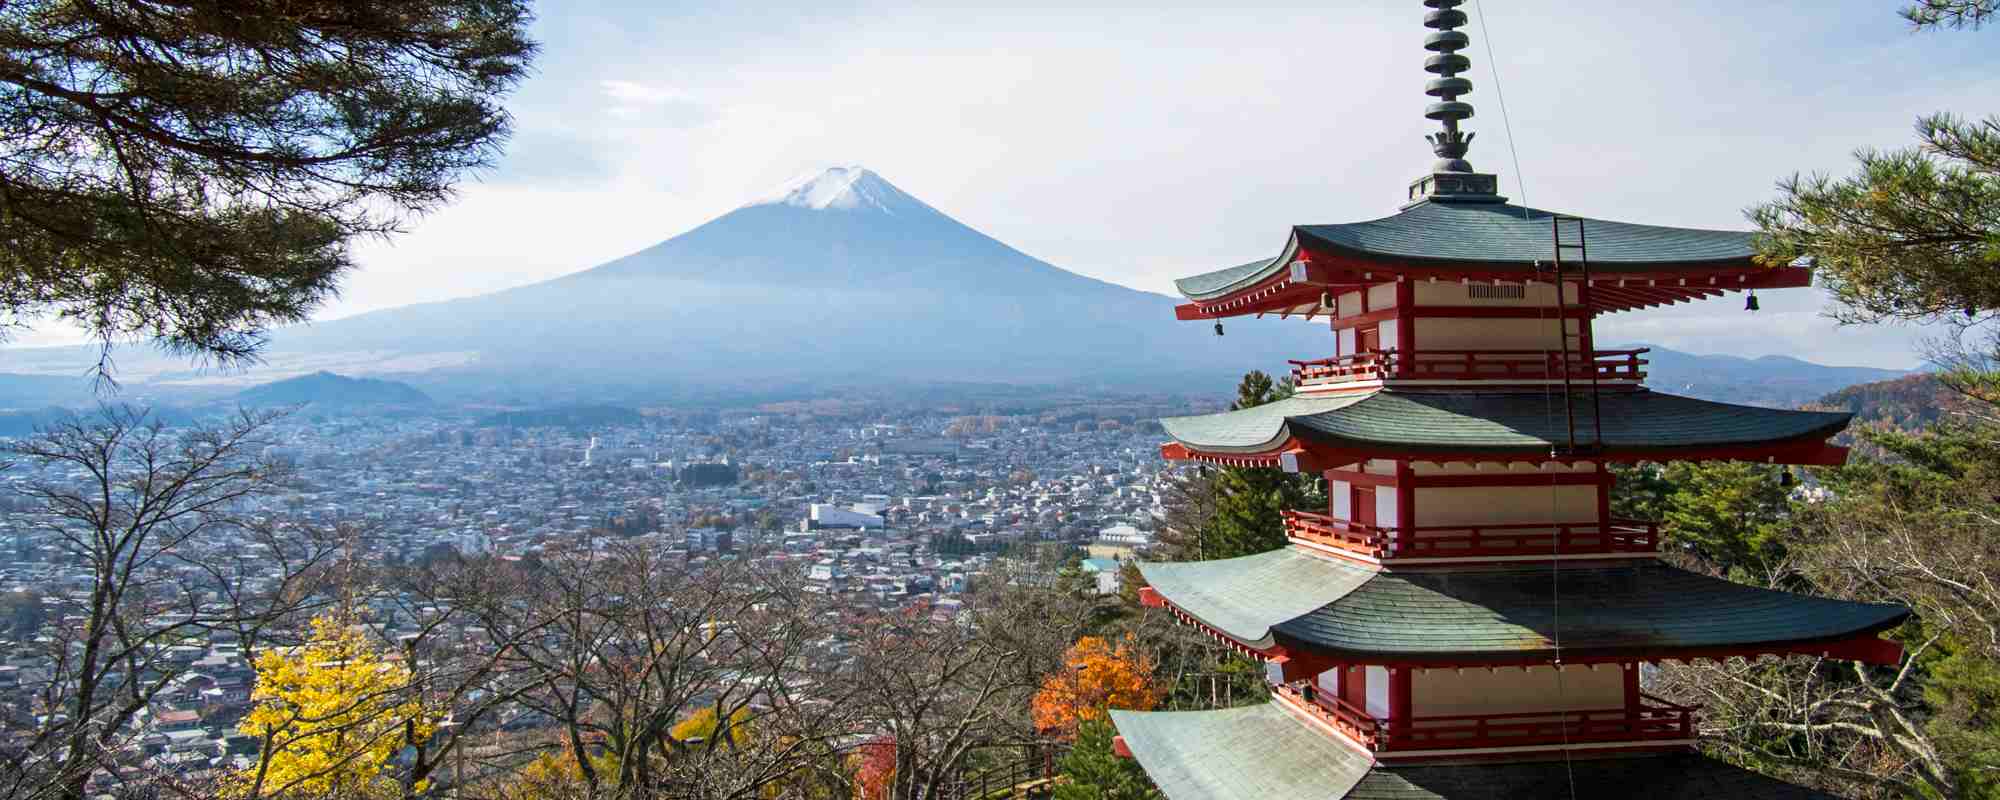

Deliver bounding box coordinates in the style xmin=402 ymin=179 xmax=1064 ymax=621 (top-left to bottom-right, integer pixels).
xmin=1160 ymin=390 xmax=1852 ymax=466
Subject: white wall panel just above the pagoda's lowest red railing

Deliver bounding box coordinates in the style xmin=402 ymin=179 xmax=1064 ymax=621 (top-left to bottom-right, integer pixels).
xmin=1408 ymin=664 xmax=1624 ymax=718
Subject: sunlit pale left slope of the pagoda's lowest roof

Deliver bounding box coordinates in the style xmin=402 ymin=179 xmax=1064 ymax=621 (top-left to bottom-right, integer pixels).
xmin=1112 ymin=702 xmax=1370 ymax=800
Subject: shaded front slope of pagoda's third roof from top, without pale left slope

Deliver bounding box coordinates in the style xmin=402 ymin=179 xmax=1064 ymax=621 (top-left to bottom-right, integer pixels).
xmin=1272 ymin=562 xmax=1910 ymax=662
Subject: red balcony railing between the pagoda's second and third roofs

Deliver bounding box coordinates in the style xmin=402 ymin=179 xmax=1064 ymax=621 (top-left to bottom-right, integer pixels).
xmin=1284 ymin=510 xmax=1660 ymax=558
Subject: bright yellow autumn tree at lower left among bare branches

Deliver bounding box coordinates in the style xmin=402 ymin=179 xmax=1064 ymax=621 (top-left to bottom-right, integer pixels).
xmin=234 ymin=614 xmax=436 ymax=798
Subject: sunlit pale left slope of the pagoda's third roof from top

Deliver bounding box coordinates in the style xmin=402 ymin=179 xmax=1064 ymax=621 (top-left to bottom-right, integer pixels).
xmin=1138 ymin=548 xmax=1374 ymax=646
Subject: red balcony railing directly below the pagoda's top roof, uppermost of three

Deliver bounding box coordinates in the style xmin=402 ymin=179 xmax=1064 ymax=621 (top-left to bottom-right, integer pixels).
xmin=1292 ymin=348 xmax=1650 ymax=386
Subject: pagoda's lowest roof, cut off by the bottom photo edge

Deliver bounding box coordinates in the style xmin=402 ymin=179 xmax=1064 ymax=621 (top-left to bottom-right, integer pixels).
xmin=1110 ymin=702 xmax=1834 ymax=800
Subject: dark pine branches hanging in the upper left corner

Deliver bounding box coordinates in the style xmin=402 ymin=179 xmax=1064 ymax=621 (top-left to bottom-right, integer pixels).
xmin=0 ymin=0 xmax=536 ymax=362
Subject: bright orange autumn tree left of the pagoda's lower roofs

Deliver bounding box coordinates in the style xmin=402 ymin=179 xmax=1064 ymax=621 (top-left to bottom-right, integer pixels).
xmin=1032 ymin=634 xmax=1160 ymax=736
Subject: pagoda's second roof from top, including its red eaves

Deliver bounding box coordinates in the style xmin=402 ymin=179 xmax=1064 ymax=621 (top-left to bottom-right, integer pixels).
xmin=1160 ymin=390 xmax=1852 ymax=472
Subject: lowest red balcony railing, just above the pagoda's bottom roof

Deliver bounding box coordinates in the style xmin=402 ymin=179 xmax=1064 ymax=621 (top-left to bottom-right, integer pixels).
xmin=1278 ymin=684 xmax=1698 ymax=752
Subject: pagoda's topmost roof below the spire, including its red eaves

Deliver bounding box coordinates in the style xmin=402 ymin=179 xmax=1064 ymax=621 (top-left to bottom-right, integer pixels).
xmin=1176 ymin=198 xmax=1812 ymax=320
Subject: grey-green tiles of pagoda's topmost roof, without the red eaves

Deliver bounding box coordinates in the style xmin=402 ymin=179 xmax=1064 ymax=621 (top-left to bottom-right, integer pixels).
xmin=1174 ymin=200 xmax=1756 ymax=300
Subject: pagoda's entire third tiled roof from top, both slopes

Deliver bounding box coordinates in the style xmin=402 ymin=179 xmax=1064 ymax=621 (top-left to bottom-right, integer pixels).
xmin=1140 ymin=548 xmax=1910 ymax=666
